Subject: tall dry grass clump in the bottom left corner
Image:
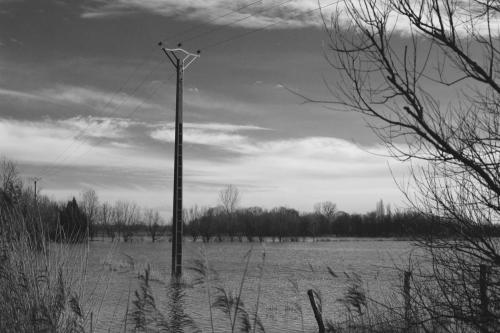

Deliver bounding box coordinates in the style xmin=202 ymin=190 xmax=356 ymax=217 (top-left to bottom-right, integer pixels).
xmin=0 ymin=212 xmax=87 ymax=333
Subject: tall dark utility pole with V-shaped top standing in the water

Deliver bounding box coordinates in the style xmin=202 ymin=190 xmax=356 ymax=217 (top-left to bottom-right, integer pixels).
xmin=158 ymin=42 xmax=200 ymax=279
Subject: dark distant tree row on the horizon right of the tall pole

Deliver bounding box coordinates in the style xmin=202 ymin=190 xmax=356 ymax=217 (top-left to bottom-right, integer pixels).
xmin=185 ymin=198 xmax=468 ymax=242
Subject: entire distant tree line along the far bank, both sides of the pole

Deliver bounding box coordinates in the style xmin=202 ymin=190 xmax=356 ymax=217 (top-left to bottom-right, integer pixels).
xmin=0 ymin=158 xmax=500 ymax=242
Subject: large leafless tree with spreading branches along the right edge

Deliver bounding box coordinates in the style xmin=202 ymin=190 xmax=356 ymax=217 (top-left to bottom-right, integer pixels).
xmin=318 ymin=0 xmax=500 ymax=332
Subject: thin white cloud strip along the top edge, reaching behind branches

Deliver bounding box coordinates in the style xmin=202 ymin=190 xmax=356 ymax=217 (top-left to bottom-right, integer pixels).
xmin=81 ymin=0 xmax=500 ymax=37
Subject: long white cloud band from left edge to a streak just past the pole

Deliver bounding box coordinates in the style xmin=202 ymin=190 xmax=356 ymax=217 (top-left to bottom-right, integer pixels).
xmin=0 ymin=116 xmax=267 ymax=169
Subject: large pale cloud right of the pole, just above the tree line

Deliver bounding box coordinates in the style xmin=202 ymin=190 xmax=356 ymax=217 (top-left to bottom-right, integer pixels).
xmin=176 ymin=137 xmax=406 ymax=212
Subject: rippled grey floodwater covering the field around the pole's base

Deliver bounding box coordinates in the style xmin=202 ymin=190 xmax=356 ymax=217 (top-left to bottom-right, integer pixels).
xmin=78 ymin=238 xmax=412 ymax=332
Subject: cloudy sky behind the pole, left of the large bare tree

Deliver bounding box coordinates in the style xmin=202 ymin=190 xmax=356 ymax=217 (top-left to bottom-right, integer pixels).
xmin=0 ymin=0 xmax=405 ymax=215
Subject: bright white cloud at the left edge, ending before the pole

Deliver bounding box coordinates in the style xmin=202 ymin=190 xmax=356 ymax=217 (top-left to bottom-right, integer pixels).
xmin=0 ymin=117 xmax=164 ymax=169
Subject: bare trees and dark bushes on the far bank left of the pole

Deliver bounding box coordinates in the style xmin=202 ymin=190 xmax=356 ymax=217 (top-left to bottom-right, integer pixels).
xmin=0 ymin=157 xmax=167 ymax=244
